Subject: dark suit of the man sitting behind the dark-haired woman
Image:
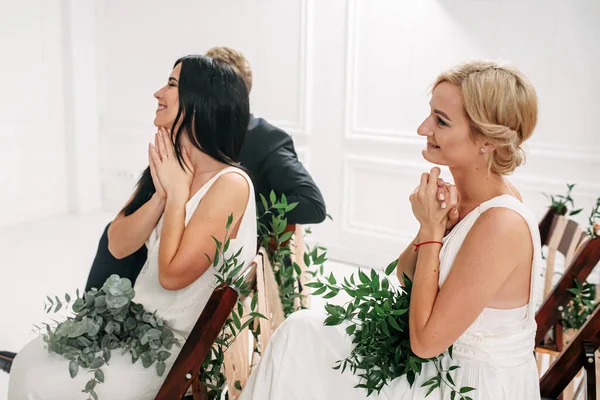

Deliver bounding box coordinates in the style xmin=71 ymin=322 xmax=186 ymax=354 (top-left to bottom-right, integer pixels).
xmin=85 ymin=116 xmax=326 ymax=291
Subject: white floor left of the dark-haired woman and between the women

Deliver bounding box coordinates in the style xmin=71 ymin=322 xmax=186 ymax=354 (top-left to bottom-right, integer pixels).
xmin=0 ymin=214 xmax=366 ymax=400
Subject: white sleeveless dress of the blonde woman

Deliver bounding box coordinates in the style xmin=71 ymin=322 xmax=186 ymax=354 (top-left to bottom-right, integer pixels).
xmin=240 ymin=196 xmax=540 ymax=400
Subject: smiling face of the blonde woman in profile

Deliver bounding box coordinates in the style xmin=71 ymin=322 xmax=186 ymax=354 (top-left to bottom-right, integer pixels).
xmin=417 ymin=82 xmax=487 ymax=168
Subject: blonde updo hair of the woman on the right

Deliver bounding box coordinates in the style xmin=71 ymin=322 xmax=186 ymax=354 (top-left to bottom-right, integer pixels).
xmin=433 ymin=61 xmax=538 ymax=175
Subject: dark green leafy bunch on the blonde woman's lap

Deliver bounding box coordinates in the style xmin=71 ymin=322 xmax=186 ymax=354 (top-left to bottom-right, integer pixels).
xmin=307 ymin=260 xmax=475 ymax=400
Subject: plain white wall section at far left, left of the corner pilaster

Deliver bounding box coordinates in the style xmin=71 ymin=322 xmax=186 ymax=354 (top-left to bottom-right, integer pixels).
xmin=0 ymin=0 xmax=68 ymax=227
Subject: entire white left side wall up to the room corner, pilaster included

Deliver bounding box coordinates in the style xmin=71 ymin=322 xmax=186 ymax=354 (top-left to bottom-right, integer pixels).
xmin=0 ymin=0 xmax=102 ymax=227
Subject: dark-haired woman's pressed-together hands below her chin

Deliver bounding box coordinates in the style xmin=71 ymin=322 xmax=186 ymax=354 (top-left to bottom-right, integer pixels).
xmin=148 ymin=127 xmax=194 ymax=201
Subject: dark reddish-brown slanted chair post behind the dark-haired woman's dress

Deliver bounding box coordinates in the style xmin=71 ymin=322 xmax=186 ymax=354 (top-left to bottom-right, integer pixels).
xmin=156 ymin=258 xmax=260 ymax=400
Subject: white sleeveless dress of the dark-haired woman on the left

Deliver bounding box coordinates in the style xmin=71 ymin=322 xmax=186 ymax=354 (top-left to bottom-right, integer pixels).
xmin=8 ymin=167 xmax=257 ymax=400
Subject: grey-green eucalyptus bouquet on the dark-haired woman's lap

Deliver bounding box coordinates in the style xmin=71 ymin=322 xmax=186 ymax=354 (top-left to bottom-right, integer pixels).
xmin=43 ymin=275 xmax=180 ymax=400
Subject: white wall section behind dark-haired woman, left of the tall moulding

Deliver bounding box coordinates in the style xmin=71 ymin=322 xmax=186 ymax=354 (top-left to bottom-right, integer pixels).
xmin=98 ymin=0 xmax=307 ymax=210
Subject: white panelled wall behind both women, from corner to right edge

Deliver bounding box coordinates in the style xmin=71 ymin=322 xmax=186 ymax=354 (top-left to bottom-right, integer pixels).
xmin=98 ymin=0 xmax=600 ymax=266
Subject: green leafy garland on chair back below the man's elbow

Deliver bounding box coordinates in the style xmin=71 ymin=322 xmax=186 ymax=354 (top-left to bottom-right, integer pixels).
xmin=258 ymin=191 xmax=327 ymax=318
